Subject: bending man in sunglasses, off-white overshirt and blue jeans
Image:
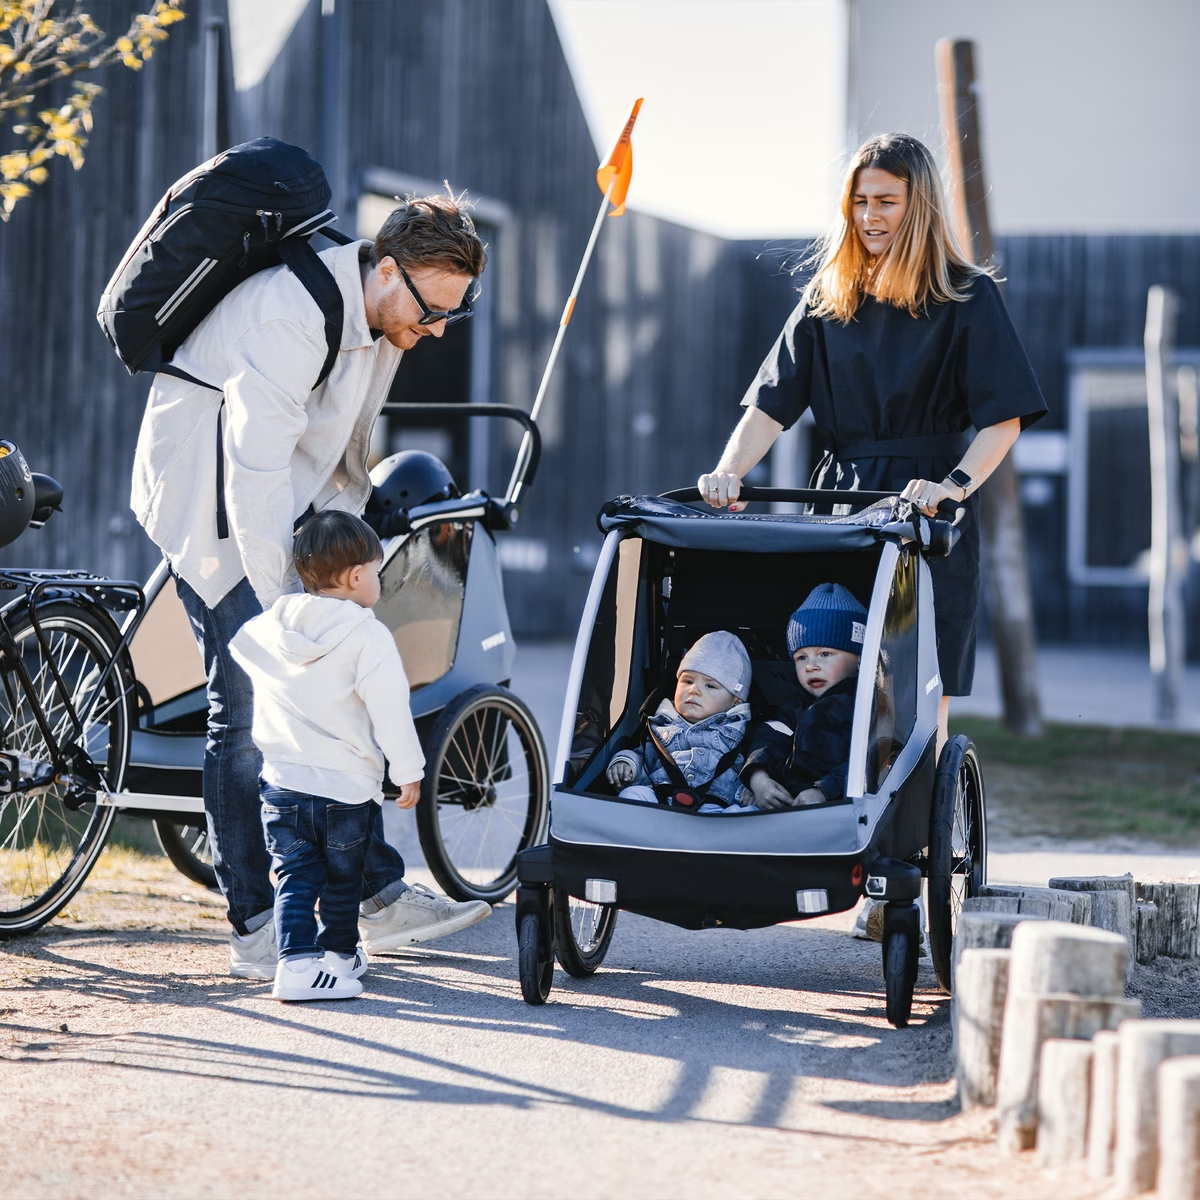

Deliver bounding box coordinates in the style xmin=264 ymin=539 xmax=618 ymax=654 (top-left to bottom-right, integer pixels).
xmin=131 ymin=196 xmax=491 ymax=979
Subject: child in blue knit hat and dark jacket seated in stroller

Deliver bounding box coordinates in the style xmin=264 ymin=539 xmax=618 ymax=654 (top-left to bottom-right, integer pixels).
xmin=742 ymin=583 xmax=866 ymax=810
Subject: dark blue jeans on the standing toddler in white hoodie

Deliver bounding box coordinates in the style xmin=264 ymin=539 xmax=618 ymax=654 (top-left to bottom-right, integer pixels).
xmin=262 ymin=784 xmax=376 ymax=958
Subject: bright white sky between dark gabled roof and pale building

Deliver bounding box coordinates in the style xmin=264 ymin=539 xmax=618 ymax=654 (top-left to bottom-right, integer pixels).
xmin=550 ymin=0 xmax=846 ymax=238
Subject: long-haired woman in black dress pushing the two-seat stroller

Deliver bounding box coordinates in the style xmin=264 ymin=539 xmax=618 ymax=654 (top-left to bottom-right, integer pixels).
xmin=697 ymin=133 xmax=1046 ymax=750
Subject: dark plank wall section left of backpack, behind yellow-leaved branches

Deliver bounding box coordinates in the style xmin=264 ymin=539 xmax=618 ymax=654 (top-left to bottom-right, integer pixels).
xmin=0 ymin=0 xmax=224 ymax=578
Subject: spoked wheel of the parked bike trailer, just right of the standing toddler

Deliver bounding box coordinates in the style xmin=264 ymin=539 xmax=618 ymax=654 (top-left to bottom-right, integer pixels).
xmin=416 ymin=685 xmax=550 ymax=904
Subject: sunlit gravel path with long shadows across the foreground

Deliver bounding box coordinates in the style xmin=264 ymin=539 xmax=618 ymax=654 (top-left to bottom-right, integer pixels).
xmin=0 ymin=852 xmax=1176 ymax=1200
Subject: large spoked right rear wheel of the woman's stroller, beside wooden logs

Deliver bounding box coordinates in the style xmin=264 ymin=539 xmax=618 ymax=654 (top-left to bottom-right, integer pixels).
xmin=929 ymin=733 xmax=988 ymax=992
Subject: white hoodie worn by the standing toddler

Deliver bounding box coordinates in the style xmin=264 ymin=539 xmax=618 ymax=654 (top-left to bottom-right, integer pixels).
xmin=229 ymin=595 xmax=425 ymax=804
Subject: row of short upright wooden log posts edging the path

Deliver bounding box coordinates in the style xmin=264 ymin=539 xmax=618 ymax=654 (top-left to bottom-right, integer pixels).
xmin=953 ymin=875 xmax=1200 ymax=1200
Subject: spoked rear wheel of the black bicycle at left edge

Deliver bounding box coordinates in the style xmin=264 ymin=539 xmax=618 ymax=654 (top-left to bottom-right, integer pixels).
xmin=0 ymin=601 xmax=133 ymax=937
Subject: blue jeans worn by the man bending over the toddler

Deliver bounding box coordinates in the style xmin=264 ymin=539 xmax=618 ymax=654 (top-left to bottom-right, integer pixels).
xmin=175 ymin=575 xmax=406 ymax=935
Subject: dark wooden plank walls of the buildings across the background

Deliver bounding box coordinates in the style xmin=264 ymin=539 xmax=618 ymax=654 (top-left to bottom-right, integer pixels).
xmin=0 ymin=0 xmax=1200 ymax=642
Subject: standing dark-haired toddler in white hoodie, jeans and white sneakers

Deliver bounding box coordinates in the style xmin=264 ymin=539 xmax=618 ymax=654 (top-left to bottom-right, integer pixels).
xmin=230 ymin=510 xmax=425 ymax=1000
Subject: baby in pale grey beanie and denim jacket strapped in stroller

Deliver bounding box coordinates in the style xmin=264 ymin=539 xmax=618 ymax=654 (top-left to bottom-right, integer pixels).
xmin=607 ymin=630 xmax=754 ymax=812
